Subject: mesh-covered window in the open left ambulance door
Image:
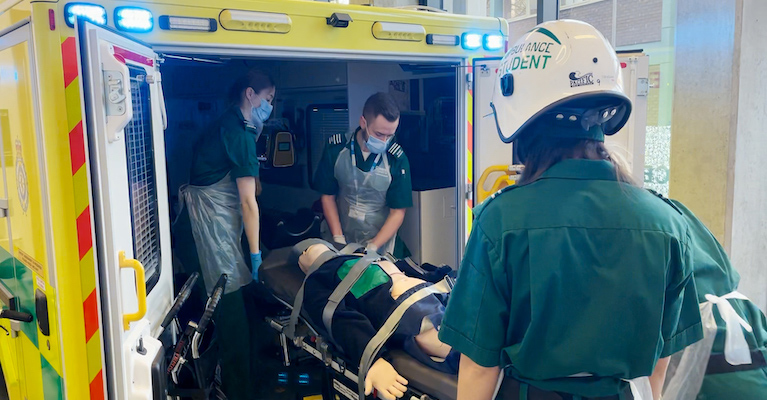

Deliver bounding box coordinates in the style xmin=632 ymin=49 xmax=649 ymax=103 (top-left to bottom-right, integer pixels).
xmin=125 ymin=67 xmax=160 ymax=293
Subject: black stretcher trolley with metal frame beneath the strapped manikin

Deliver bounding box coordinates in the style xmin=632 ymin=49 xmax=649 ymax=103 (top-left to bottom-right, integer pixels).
xmin=259 ymin=247 xmax=458 ymax=400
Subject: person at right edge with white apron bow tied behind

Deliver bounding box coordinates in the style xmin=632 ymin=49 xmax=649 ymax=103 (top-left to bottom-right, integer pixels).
xmin=658 ymin=195 xmax=767 ymax=400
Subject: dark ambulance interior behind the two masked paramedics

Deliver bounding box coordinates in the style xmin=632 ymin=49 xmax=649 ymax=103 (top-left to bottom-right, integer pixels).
xmin=162 ymin=56 xmax=460 ymax=267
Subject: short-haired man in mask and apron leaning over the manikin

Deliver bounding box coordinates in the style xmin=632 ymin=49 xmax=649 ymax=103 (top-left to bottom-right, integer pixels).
xmin=314 ymin=93 xmax=413 ymax=256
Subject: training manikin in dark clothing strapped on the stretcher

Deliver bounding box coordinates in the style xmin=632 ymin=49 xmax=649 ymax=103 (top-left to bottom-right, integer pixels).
xmin=298 ymin=244 xmax=458 ymax=399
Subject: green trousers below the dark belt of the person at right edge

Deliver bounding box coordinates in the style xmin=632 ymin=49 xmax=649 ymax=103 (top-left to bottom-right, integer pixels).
xmin=698 ymin=368 xmax=767 ymax=400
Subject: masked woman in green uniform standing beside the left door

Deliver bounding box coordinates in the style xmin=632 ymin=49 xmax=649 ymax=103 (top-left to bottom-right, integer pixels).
xmin=181 ymin=70 xmax=275 ymax=400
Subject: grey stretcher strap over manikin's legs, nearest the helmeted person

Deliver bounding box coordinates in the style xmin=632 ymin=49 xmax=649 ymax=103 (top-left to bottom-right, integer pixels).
xmin=357 ymin=279 xmax=452 ymax=399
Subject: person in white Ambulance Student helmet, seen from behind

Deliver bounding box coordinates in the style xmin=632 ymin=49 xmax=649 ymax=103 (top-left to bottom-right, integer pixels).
xmin=439 ymin=20 xmax=702 ymax=400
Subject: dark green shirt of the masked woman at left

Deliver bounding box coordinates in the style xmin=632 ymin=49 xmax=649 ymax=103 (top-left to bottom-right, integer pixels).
xmin=189 ymin=107 xmax=259 ymax=186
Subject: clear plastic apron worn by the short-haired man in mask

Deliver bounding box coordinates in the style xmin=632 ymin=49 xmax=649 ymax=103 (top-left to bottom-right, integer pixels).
xmin=334 ymin=135 xmax=396 ymax=254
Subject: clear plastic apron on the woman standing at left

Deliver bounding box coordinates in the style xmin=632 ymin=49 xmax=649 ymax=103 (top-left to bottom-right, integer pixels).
xmin=179 ymin=174 xmax=253 ymax=295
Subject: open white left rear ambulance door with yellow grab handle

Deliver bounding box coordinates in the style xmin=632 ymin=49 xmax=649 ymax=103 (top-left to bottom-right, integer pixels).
xmin=76 ymin=21 xmax=173 ymax=400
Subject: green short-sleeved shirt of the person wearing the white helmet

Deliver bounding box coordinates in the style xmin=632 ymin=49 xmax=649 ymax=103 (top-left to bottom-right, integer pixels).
xmin=439 ymin=160 xmax=702 ymax=397
